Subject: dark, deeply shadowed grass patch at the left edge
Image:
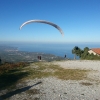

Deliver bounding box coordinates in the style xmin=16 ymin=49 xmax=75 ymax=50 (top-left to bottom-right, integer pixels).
xmin=0 ymin=69 xmax=28 ymax=89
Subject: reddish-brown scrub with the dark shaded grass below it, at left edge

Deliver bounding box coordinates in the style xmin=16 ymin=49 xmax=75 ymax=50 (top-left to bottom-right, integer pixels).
xmin=0 ymin=63 xmax=28 ymax=89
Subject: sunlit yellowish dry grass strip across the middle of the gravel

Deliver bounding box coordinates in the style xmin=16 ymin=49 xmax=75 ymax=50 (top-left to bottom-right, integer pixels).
xmin=22 ymin=62 xmax=89 ymax=80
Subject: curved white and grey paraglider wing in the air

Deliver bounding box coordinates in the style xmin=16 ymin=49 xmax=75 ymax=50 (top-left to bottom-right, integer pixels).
xmin=20 ymin=20 xmax=64 ymax=35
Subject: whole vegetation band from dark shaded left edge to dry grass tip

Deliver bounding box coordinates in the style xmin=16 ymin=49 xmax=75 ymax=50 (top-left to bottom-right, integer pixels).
xmin=0 ymin=62 xmax=89 ymax=89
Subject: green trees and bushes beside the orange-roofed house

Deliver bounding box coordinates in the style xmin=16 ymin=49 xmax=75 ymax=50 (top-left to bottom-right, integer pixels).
xmin=72 ymin=46 xmax=100 ymax=60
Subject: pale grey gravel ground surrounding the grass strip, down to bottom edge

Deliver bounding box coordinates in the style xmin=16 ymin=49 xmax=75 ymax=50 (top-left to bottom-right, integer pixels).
xmin=0 ymin=60 xmax=100 ymax=100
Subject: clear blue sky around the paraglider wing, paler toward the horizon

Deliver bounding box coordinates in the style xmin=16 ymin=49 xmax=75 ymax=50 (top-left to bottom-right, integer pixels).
xmin=0 ymin=0 xmax=100 ymax=43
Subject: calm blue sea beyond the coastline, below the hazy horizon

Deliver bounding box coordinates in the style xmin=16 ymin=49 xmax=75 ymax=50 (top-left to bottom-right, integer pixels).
xmin=0 ymin=42 xmax=100 ymax=59
